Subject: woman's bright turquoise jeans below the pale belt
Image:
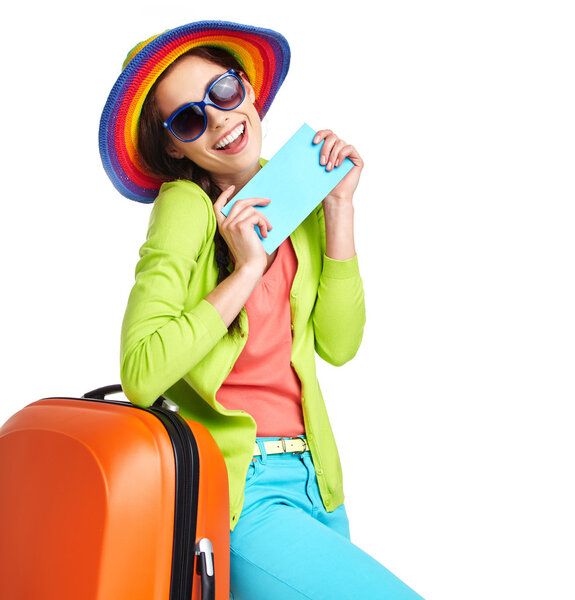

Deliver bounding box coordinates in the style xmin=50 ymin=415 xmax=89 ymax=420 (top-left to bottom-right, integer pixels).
xmin=230 ymin=438 xmax=423 ymax=600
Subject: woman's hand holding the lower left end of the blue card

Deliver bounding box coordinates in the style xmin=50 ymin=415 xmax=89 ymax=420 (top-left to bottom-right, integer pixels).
xmin=214 ymin=185 xmax=272 ymax=277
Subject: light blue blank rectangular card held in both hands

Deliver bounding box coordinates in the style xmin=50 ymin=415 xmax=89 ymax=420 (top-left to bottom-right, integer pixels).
xmin=222 ymin=123 xmax=353 ymax=254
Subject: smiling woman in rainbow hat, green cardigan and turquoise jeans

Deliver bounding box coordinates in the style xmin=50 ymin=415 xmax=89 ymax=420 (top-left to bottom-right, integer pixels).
xmin=100 ymin=22 xmax=426 ymax=600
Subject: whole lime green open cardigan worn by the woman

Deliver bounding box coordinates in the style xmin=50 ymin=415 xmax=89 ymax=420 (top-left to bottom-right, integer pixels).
xmin=121 ymin=176 xmax=365 ymax=529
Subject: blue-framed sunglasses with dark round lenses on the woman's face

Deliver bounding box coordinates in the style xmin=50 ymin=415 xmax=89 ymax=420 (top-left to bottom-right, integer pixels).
xmin=163 ymin=69 xmax=246 ymax=142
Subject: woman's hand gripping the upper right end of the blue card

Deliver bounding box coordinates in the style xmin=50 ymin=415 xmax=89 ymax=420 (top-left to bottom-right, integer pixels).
xmin=313 ymin=129 xmax=363 ymax=205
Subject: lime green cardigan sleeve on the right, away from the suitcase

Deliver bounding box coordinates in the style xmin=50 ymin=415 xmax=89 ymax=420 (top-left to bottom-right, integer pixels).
xmin=313 ymin=208 xmax=365 ymax=366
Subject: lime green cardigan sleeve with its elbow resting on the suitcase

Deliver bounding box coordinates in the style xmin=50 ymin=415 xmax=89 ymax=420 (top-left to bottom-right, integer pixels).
xmin=120 ymin=182 xmax=227 ymax=406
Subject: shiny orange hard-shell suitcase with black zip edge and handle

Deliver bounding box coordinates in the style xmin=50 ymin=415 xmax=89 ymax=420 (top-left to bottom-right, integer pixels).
xmin=0 ymin=386 xmax=229 ymax=600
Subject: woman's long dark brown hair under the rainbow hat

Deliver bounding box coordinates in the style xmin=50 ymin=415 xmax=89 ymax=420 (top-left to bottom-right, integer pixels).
xmin=138 ymin=46 xmax=259 ymax=331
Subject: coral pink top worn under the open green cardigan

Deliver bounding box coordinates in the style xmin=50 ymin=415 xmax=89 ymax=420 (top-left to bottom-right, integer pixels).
xmin=216 ymin=238 xmax=305 ymax=437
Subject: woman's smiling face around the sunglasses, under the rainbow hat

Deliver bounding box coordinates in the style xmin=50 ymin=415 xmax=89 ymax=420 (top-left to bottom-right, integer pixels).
xmin=156 ymin=56 xmax=262 ymax=181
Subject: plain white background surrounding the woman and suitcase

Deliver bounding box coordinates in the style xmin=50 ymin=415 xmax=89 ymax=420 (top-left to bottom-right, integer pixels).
xmin=0 ymin=0 xmax=575 ymax=600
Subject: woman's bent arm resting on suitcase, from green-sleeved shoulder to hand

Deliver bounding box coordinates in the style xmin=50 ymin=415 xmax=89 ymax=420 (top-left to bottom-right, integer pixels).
xmin=120 ymin=182 xmax=269 ymax=406
